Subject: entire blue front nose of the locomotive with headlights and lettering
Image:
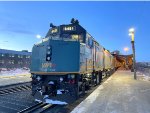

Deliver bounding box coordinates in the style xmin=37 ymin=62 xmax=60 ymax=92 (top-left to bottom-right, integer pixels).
xmin=31 ymin=40 xmax=80 ymax=74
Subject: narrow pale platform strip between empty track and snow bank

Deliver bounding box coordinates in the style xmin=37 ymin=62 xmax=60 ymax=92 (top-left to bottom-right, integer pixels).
xmin=0 ymin=74 xmax=31 ymax=87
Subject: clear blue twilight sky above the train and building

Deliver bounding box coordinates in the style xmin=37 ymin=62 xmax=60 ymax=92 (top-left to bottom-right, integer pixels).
xmin=0 ymin=1 xmax=150 ymax=61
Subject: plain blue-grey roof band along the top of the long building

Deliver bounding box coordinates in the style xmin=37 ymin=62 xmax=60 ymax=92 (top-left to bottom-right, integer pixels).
xmin=0 ymin=49 xmax=31 ymax=55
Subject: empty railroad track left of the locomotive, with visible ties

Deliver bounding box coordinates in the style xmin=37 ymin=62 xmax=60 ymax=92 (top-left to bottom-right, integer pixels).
xmin=0 ymin=82 xmax=31 ymax=96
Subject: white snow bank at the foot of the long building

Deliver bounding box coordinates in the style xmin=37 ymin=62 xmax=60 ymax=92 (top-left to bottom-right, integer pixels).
xmin=0 ymin=68 xmax=30 ymax=76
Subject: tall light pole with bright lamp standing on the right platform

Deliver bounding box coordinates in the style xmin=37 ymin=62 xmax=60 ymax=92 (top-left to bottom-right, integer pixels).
xmin=129 ymin=28 xmax=136 ymax=79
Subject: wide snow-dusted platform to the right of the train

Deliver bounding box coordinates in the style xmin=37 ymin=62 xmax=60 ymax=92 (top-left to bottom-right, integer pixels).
xmin=71 ymin=70 xmax=150 ymax=113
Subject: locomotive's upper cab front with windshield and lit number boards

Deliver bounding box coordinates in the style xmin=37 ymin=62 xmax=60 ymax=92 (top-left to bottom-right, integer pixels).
xmin=46 ymin=24 xmax=85 ymax=43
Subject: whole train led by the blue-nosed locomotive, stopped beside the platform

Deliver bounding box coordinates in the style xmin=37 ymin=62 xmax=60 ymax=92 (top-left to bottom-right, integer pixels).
xmin=31 ymin=19 xmax=115 ymax=104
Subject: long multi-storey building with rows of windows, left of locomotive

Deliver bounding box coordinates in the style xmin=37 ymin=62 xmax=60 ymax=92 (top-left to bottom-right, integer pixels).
xmin=0 ymin=49 xmax=31 ymax=68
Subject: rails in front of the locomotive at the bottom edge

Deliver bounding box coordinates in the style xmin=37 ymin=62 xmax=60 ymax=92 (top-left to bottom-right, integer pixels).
xmin=18 ymin=102 xmax=56 ymax=113
